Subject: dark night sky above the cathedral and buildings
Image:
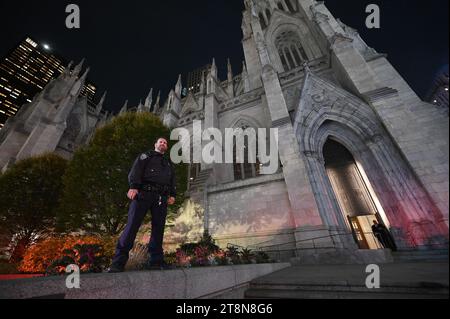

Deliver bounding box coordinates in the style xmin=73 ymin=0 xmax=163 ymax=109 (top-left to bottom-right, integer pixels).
xmin=0 ymin=0 xmax=449 ymax=114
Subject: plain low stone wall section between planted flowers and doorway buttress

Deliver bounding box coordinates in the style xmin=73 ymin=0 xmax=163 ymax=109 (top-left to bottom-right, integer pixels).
xmin=208 ymin=174 xmax=295 ymax=247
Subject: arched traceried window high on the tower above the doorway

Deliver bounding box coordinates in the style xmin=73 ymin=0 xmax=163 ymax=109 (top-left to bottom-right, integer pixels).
xmin=275 ymin=31 xmax=308 ymax=71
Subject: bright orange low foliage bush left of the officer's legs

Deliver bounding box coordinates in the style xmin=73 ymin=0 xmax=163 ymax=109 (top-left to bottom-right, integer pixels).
xmin=19 ymin=236 xmax=115 ymax=274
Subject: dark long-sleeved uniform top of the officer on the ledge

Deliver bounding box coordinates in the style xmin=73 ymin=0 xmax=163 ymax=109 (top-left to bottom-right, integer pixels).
xmin=128 ymin=151 xmax=176 ymax=197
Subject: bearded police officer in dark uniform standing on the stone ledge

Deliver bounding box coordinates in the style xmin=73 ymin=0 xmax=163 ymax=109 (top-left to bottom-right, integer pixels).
xmin=109 ymin=138 xmax=176 ymax=273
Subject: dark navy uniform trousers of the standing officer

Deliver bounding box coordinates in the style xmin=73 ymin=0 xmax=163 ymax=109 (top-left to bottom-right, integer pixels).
xmin=113 ymin=192 xmax=167 ymax=267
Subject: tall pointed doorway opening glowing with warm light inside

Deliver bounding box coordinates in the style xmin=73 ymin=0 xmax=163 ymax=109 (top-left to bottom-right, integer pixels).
xmin=323 ymin=138 xmax=385 ymax=249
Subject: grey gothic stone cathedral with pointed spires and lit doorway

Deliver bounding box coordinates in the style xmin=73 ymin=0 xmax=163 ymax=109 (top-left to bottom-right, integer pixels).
xmin=0 ymin=0 xmax=449 ymax=258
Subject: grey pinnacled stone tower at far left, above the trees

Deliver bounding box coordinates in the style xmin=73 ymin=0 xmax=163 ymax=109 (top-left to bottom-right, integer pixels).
xmin=0 ymin=62 xmax=105 ymax=171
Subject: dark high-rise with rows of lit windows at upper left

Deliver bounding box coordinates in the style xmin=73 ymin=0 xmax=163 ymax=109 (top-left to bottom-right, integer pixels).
xmin=0 ymin=37 xmax=97 ymax=129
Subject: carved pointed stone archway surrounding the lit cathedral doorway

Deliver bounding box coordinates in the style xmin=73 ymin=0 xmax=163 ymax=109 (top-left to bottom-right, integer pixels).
xmin=295 ymin=74 xmax=439 ymax=247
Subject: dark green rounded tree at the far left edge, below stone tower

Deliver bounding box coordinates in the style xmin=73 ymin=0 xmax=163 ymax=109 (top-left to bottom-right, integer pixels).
xmin=0 ymin=154 xmax=67 ymax=263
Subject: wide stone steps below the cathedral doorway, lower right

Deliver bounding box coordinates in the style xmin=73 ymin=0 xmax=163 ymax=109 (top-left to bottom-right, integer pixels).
xmin=245 ymin=262 xmax=449 ymax=299
